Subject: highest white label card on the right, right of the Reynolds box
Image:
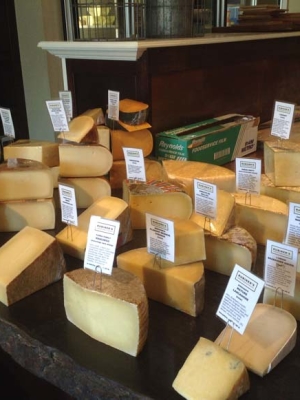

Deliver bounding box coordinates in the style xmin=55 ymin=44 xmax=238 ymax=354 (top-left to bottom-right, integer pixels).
xmin=271 ymin=101 xmax=295 ymax=139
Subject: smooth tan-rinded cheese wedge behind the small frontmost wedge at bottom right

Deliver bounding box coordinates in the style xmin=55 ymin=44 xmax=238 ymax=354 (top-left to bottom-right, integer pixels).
xmin=216 ymin=303 xmax=297 ymax=376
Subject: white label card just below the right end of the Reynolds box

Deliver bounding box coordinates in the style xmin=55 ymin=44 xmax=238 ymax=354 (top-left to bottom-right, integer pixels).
xmin=235 ymin=158 xmax=261 ymax=194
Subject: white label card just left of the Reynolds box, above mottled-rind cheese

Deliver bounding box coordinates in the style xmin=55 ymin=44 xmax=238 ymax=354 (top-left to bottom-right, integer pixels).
xmin=123 ymin=147 xmax=146 ymax=182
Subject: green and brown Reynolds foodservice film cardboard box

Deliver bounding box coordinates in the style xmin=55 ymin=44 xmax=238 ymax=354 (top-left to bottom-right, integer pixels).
xmin=155 ymin=114 xmax=259 ymax=165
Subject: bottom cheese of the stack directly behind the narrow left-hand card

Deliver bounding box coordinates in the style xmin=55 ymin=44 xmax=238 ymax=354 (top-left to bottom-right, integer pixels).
xmin=59 ymin=177 xmax=111 ymax=208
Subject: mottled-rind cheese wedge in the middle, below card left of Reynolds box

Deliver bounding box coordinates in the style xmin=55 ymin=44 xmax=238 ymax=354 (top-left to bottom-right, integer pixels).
xmin=123 ymin=180 xmax=193 ymax=229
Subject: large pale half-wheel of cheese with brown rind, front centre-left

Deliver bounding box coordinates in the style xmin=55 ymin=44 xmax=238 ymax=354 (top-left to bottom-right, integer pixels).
xmin=63 ymin=268 xmax=149 ymax=356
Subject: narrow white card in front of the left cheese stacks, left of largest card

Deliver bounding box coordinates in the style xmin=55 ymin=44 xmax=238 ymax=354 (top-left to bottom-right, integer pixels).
xmin=58 ymin=183 xmax=78 ymax=226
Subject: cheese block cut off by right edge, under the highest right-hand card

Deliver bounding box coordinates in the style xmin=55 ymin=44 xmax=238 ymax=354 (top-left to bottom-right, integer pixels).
xmin=264 ymin=140 xmax=300 ymax=186
